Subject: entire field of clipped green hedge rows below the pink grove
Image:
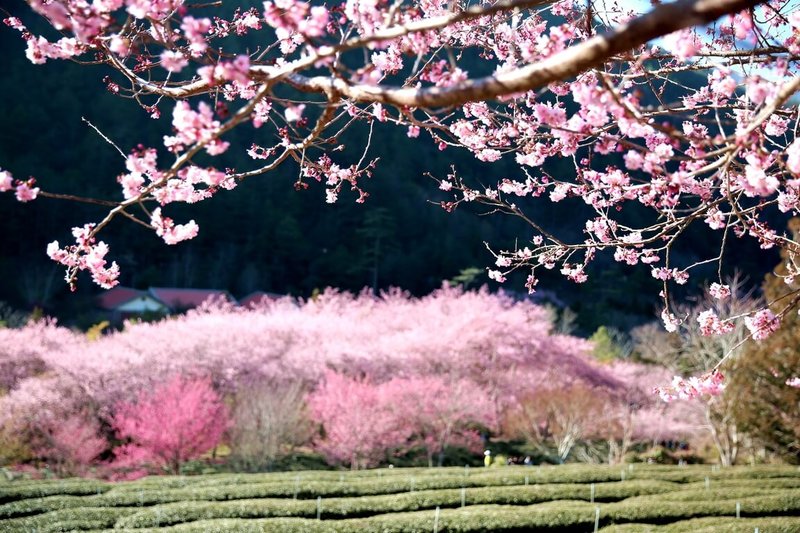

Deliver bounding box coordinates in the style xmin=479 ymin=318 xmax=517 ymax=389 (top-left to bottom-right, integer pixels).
xmin=0 ymin=464 xmax=800 ymax=533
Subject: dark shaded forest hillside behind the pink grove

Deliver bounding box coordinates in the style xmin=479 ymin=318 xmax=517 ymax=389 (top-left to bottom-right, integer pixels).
xmin=0 ymin=6 xmax=777 ymax=333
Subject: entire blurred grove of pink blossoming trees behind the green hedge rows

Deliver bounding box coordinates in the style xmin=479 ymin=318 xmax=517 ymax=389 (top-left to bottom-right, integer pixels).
xmin=0 ymin=287 xmax=708 ymax=473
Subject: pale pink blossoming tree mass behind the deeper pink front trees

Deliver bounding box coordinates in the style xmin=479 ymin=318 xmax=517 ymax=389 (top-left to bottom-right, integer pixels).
xmin=0 ymin=287 xmax=588 ymax=462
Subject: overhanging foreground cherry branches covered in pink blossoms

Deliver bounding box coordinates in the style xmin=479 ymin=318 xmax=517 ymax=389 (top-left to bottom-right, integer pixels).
xmin=0 ymin=0 xmax=800 ymax=350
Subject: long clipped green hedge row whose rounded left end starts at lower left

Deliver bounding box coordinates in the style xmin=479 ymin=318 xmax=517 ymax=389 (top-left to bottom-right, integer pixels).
xmin=111 ymin=481 xmax=674 ymax=527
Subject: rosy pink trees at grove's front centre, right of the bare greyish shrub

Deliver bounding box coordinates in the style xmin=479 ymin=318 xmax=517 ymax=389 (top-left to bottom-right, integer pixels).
xmin=309 ymin=373 xmax=496 ymax=468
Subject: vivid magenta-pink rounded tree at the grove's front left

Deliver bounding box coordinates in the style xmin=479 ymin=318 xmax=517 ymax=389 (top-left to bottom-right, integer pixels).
xmin=112 ymin=375 xmax=229 ymax=474
